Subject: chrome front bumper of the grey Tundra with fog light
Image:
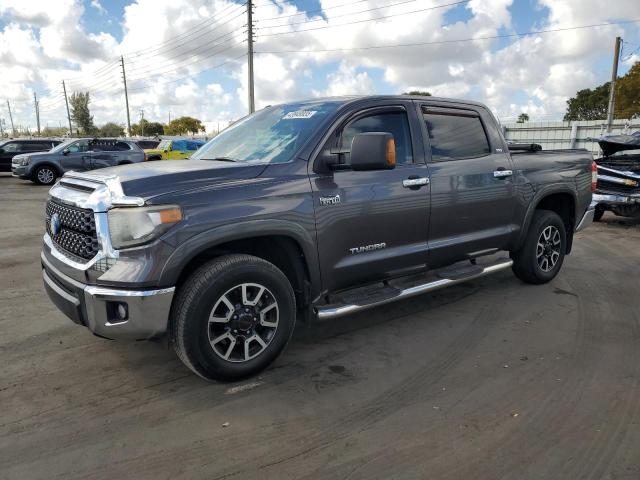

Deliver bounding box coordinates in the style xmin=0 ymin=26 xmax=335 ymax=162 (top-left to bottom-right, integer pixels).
xmin=41 ymin=253 xmax=175 ymax=340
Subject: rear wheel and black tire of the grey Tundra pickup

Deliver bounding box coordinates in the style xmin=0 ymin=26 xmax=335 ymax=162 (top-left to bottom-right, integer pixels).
xmin=511 ymin=210 xmax=567 ymax=285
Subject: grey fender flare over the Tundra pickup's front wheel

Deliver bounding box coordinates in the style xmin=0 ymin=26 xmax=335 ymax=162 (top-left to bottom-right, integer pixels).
xmin=160 ymin=219 xmax=320 ymax=288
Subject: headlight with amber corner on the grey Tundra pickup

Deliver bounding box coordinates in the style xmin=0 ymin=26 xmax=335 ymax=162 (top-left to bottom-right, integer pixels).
xmin=107 ymin=205 xmax=182 ymax=249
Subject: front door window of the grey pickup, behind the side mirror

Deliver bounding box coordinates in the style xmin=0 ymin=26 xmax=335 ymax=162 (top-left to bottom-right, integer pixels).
xmin=339 ymin=112 xmax=413 ymax=165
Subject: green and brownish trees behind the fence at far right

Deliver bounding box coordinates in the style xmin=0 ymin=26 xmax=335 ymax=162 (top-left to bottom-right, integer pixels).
xmin=564 ymin=62 xmax=640 ymax=121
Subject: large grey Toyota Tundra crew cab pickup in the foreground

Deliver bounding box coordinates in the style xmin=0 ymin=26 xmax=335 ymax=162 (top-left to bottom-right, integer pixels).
xmin=41 ymin=96 xmax=595 ymax=380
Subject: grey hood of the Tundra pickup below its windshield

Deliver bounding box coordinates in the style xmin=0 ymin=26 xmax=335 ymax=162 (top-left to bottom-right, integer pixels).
xmin=75 ymin=160 xmax=266 ymax=200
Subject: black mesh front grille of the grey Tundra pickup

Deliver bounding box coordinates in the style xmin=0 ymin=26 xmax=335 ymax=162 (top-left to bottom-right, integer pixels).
xmin=46 ymin=200 xmax=100 ymax=261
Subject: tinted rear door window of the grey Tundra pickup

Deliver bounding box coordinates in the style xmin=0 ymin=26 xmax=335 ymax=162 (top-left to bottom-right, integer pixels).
xmin=423 ymin=108 xmax=491 ymax=162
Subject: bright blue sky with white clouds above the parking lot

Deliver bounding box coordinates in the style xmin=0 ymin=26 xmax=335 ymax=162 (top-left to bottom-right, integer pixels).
xmin=0 ymin=0 xmax=640 ymax=131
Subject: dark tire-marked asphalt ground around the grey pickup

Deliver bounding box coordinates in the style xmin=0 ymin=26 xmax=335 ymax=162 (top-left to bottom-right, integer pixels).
xmin=0 ymin=175 xmax=640 ymax=480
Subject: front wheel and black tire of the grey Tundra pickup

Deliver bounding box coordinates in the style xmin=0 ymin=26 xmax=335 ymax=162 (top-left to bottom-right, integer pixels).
xmin=170 ymin=255 xmax=296 ymax=381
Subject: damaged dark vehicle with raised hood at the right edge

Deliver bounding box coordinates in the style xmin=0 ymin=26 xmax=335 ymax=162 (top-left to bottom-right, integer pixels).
xmin=593 ymin=131 xmax=640 ymax=221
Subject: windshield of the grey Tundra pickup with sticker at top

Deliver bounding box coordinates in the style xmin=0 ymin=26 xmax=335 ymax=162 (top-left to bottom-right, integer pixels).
xmin=191 ymin=102 xmax=340 ymax=163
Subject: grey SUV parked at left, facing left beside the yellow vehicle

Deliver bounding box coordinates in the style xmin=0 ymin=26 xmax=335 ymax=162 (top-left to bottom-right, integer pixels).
xmin=11 ymin=138 xmax=145 ymax=185
